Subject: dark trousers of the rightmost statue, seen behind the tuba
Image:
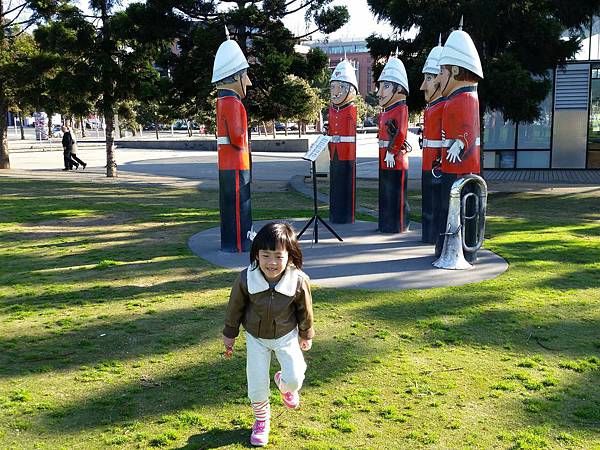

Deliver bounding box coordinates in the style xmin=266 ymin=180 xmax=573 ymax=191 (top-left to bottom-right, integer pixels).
xmin=435 ymin=173 xmax=477 ymax=263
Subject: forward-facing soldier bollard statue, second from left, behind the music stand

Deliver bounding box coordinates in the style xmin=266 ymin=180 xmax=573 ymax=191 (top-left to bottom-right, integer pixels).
xmin=328 ymin=59 xmax=358 ymax=223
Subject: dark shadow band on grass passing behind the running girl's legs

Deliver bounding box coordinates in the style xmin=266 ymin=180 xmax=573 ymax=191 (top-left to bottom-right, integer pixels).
xmin=32 ymin=339 xmax=382 ymax=434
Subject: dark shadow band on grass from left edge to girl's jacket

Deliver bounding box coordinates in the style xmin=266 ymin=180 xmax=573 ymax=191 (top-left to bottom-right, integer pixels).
xmin=0 ymin=298 xmax=233 ymax=378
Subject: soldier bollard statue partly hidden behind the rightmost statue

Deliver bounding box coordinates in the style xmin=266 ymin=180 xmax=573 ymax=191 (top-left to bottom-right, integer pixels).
xmin=421 ymin=35 xmax=445 ymax=244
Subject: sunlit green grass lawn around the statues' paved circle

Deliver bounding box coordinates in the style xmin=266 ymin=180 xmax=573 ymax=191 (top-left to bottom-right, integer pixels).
xmin=0 ymin=178 xmax=600 ymax=449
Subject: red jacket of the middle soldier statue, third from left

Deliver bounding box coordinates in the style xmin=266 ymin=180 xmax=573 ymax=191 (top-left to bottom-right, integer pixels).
xmin=378 ymin=100 xmax=408 ymax=170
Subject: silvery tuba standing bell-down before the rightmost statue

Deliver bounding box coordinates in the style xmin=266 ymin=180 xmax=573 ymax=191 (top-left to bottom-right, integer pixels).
xmin=433 ymin=174 xmax=487 ymax=270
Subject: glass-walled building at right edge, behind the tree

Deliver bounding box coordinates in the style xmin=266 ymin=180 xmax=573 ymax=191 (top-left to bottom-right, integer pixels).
xmin=483 ymin=17 xmax=600 ymax=169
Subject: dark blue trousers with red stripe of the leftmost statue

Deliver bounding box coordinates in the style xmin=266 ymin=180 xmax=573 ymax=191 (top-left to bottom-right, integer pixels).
xmin=219 ymin=170 xmax=252 ymax=253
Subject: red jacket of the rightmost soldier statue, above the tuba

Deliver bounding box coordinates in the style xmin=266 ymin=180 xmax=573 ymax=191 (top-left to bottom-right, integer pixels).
xmin=442 ymin=86 xmax=481 ymax=174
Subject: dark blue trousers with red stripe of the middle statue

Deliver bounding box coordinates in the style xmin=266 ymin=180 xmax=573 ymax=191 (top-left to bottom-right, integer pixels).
xmin=378 ymin=168 xmax=410 ymax=233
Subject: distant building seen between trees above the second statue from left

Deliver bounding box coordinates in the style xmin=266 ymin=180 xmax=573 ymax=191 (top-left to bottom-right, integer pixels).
xmin=303 ymin=40 xmax=376 ymax=97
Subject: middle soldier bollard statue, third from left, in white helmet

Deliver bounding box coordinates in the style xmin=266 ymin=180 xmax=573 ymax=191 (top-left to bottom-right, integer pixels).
xmin=377 ymin=51 xmax=410 ymax=233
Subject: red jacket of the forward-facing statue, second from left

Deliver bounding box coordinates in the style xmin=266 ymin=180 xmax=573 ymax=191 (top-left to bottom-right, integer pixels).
xmin=327 ymin=103 xmax=356 ymax=161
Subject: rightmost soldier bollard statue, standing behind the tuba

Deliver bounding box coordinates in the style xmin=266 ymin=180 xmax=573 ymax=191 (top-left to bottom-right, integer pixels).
xmin=435 ymin=18 xmax=483 ymax=263
